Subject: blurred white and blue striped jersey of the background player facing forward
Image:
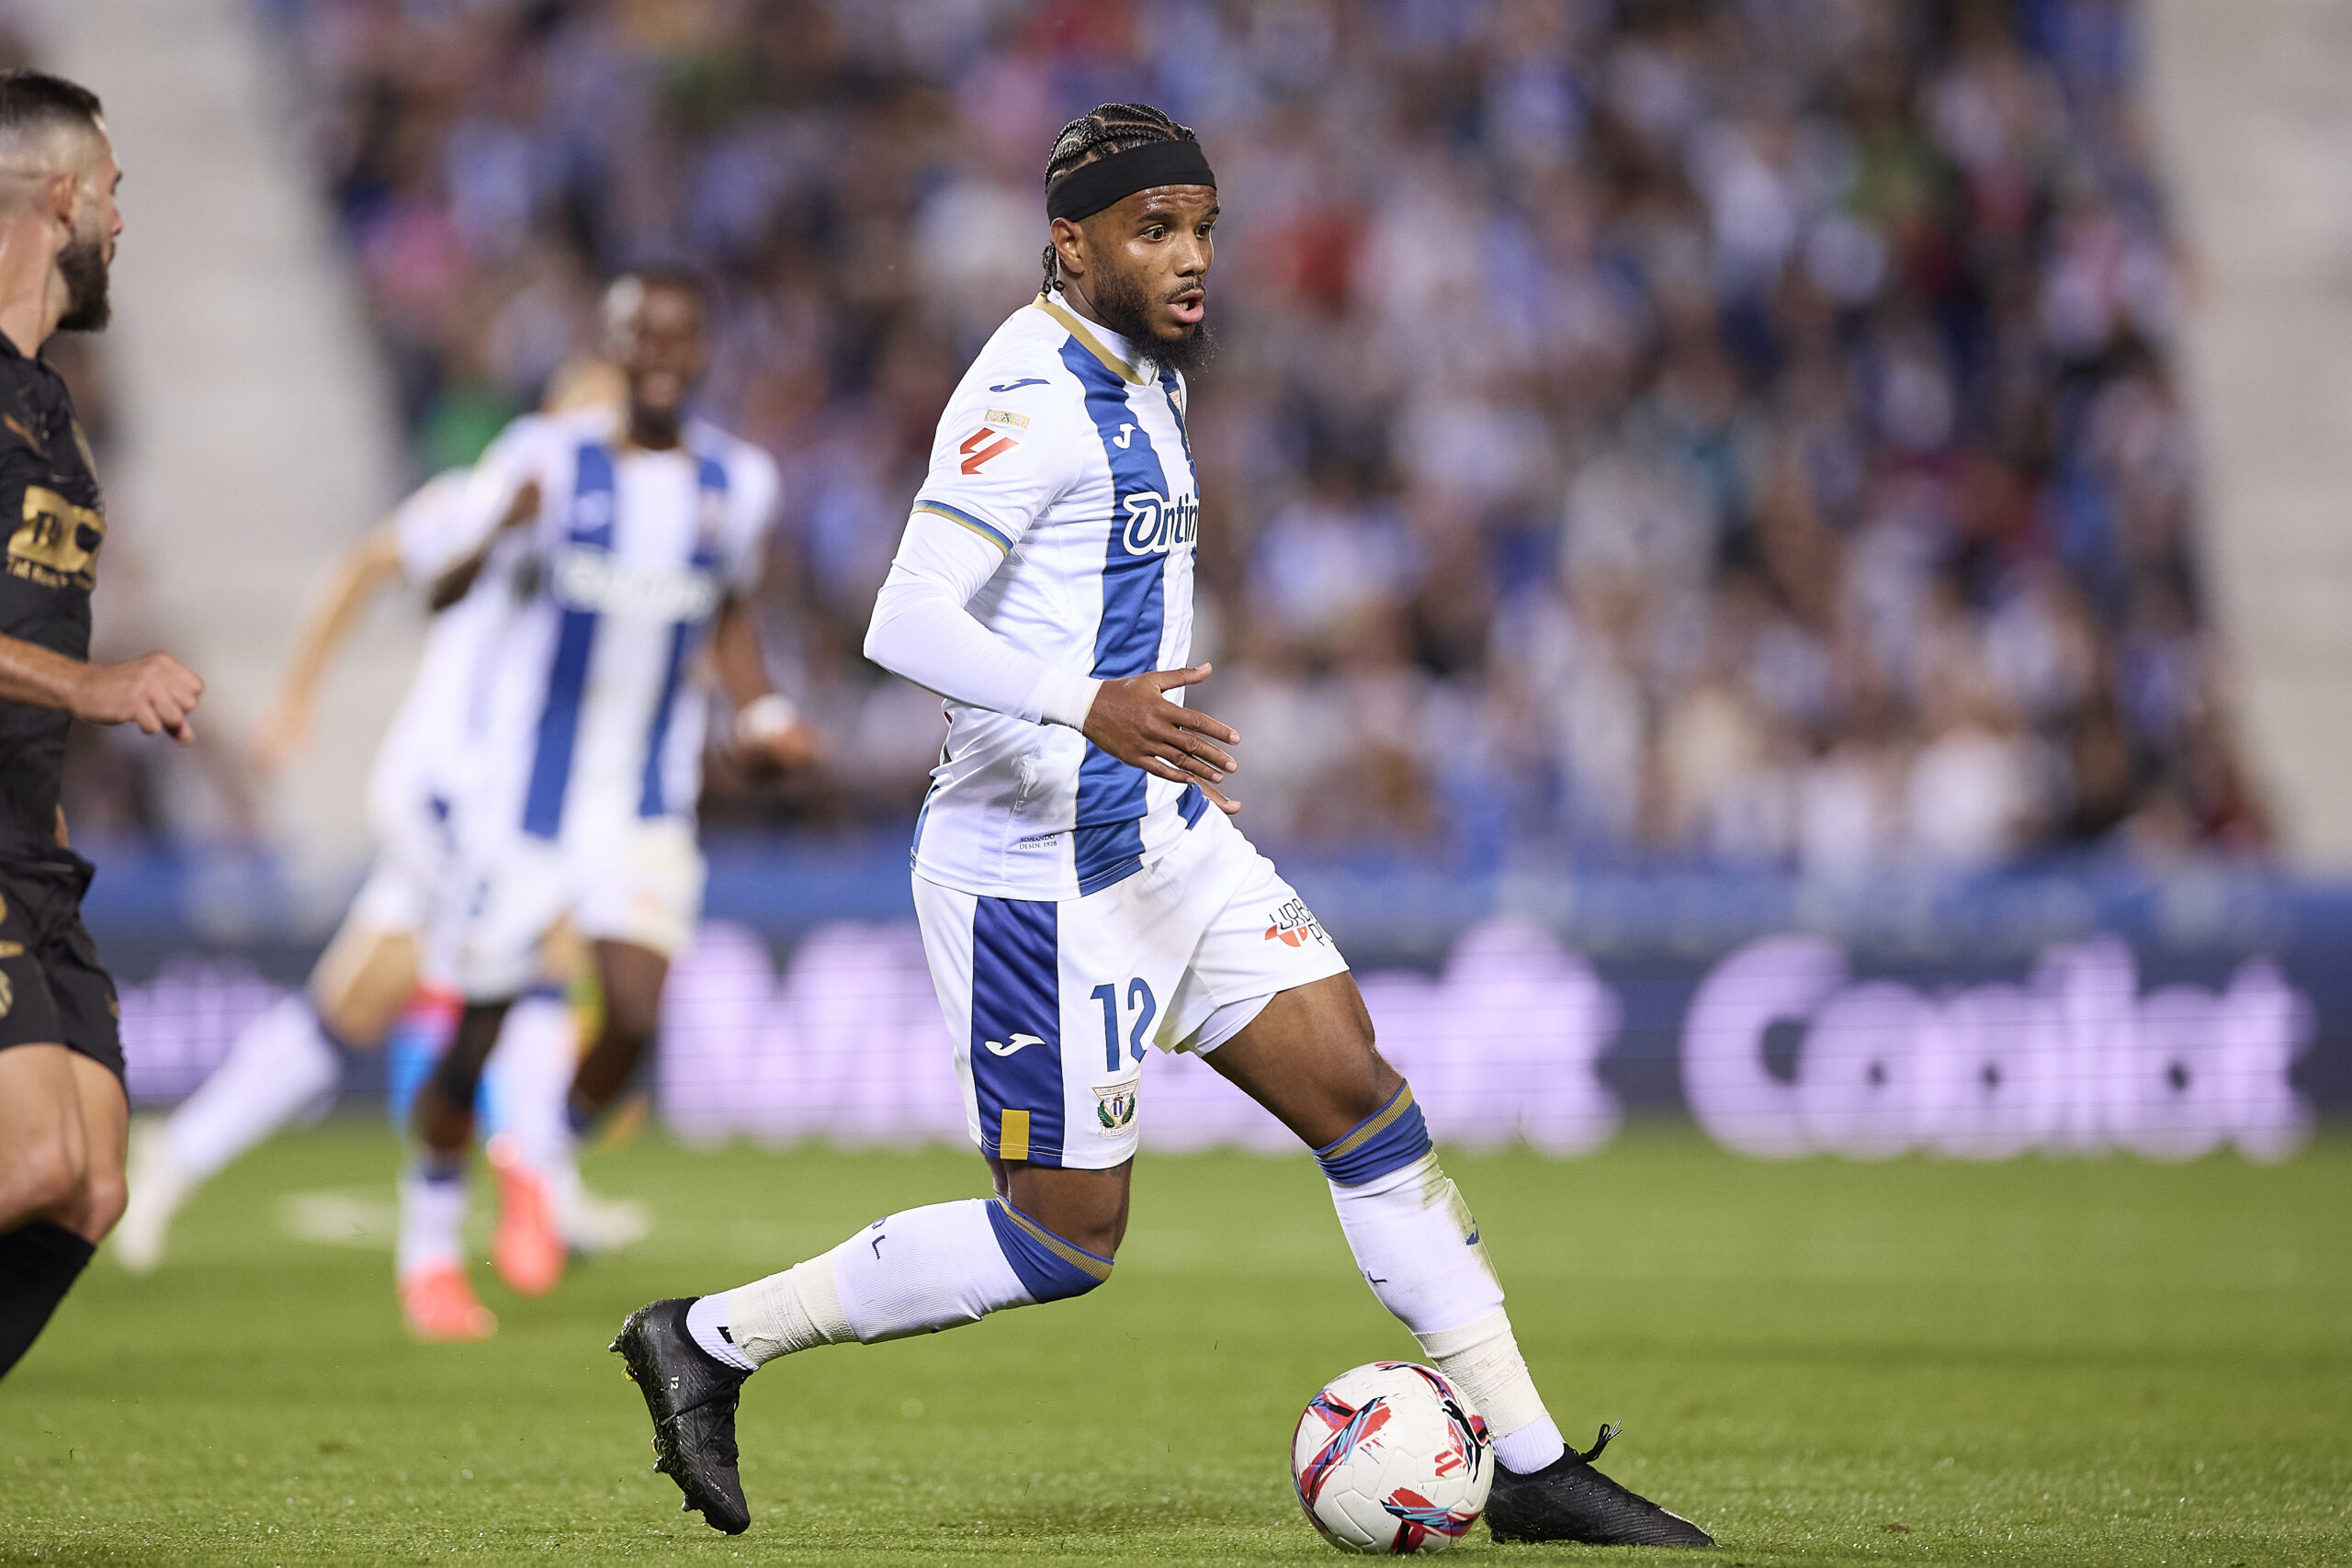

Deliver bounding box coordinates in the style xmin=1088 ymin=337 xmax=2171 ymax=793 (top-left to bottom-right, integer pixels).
xmin=437 ymin=409 xmax=776 ymax=840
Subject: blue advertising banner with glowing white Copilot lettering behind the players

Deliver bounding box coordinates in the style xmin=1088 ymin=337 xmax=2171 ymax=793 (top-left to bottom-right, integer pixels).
xmin=78 ymin=846 xmax=2352 ymax=1159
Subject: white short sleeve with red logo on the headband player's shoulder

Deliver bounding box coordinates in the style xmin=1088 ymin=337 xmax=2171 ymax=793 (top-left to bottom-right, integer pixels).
xmin=915 ymin=374 xmax=1077 ymax=552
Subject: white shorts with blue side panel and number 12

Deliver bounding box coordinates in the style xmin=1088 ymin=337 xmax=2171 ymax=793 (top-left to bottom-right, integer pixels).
xmin=915 ymin=811 xmax=1348 ymax=1170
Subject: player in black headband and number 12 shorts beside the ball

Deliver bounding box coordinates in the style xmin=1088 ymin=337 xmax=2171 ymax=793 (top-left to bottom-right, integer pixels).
xmin=614 ymin=104 xmax=1710 ymax=1544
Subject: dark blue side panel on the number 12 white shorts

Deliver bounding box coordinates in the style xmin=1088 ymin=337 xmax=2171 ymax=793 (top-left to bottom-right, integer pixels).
xmin=971 ymin=898 xmax=1063 ymax=1166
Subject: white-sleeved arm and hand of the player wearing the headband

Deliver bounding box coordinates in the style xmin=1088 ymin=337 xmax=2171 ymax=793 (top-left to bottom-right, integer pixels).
xmin=865 ymin=376 xmax=1239 ymax=811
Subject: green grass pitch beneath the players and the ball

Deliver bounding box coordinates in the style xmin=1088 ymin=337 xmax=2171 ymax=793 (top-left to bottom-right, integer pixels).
xmin=0 ymin=1122 xmax=2352 ymax=1568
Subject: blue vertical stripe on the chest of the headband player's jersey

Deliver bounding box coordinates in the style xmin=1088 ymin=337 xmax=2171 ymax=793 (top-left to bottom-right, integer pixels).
xmin=1061 ymin=339 xmax=1167 ymax=896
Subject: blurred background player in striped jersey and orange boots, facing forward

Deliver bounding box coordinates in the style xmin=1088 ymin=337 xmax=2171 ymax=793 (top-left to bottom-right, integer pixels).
xmin=395 ymin=270 xmax=814 ymax=1340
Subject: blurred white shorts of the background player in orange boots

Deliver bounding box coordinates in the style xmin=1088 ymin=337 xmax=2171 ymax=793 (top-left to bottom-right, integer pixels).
xmin=435 ymin=816 xmax=706 ymax=1001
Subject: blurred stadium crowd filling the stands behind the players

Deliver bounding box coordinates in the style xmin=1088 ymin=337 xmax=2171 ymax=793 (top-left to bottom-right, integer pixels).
xmin=248 ymin=0 xmax=2263 ymax=877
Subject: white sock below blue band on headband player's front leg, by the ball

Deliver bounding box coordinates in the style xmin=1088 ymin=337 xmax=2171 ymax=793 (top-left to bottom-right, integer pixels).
xmin=1331 ymin=1152 xmax=1566 ymax=1476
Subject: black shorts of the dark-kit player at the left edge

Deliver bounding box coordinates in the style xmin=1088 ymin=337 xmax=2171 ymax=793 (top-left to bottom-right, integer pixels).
xmin=0 ymin=856 xmax=122 ymax=1079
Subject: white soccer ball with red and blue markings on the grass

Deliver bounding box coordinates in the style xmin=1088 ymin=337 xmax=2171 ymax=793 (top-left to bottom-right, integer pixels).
xmin=1291 ymin=1361 xmax=1494 ymax=1556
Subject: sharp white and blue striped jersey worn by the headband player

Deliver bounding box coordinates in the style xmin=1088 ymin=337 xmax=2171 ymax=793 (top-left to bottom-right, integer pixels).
xmin=908 ymin=296 xmax=1206 ymax=898
